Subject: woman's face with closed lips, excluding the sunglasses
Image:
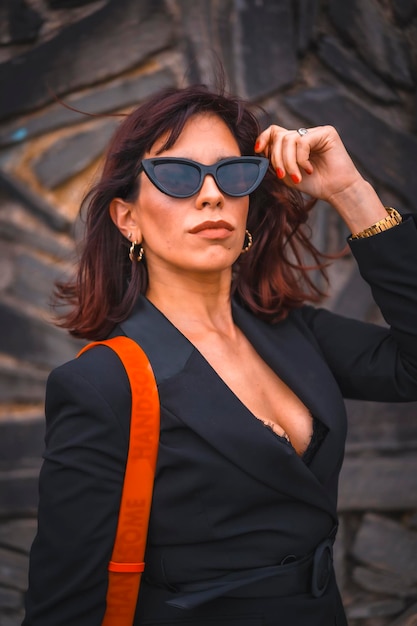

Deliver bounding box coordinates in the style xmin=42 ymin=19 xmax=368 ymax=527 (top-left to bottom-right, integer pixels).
xmin=132 ymin=114 xmax=249 ymax=280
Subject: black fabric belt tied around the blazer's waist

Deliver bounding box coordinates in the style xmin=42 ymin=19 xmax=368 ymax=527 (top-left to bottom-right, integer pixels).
xmin=167 ymin=533 xmax=334 ymax=609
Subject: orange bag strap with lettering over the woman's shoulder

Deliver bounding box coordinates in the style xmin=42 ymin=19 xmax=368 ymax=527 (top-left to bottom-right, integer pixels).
xmin=78 ymin=336 xmax=160 ymax=626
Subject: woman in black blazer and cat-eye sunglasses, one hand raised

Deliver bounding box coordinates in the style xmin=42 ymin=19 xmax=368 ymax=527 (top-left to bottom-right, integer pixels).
xmin=24 ymin=86 xmax=417 ymax=626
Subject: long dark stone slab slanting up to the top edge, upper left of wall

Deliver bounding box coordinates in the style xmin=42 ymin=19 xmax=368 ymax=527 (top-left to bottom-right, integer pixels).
xmin=0 ymin=0 xmax=173 ymax=119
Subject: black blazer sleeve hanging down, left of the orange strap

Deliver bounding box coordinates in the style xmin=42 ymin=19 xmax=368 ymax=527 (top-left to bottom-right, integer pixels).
xmin=23 ymin=346 xmax=130 ymax=626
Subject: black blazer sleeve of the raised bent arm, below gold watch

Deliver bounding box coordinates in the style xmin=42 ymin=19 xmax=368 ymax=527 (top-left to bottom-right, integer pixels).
xmin=298 ymin=216 xmax=417 ymax=402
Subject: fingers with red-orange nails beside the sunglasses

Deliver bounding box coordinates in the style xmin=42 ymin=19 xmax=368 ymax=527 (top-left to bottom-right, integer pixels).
xmin=255 ymin=125 xmax=313 ymax=184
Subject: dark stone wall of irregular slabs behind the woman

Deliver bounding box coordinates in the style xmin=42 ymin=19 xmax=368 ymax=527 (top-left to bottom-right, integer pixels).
xmin=0 ymin=0 xmax=417 ymax=626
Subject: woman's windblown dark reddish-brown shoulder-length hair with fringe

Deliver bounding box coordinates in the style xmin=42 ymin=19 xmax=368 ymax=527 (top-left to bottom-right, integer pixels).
xmin=55 ymin=85 xmax=324 ymax=339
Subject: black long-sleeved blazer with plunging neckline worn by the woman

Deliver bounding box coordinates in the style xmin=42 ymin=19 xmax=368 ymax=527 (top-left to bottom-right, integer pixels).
xmin=23 ymin=217 xmax=417 ymax=626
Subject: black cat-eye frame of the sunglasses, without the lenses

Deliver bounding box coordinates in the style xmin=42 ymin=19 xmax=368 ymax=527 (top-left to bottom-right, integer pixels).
xmin=138 ymin=156 xmax=269 ymax=198
